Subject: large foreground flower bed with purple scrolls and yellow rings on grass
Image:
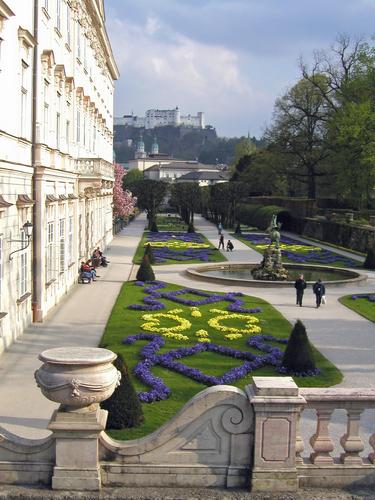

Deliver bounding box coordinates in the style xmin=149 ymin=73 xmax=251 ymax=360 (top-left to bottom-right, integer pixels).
xmin=101 ymin=281 xmax=341 ymax=439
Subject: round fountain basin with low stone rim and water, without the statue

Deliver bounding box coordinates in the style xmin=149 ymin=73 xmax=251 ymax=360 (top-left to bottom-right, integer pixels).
xmin=186 ymin=262 xmax=367 ymax=288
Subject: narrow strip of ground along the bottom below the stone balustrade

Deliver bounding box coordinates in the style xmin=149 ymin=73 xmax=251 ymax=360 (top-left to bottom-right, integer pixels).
xmin=0 ymin=486 xmax=375 ymax=500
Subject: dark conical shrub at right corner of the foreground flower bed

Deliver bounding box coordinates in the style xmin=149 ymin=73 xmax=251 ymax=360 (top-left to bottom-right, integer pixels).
xmin=281 ymin=319 xmax=316 ymax=373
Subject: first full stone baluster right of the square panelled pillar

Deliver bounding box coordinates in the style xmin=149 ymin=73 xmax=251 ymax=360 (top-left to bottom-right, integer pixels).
xmin=310 ymin=405 xmax=334 ymax=465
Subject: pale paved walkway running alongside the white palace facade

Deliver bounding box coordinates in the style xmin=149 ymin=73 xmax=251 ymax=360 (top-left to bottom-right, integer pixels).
xmin=0 ymin=214 xmax=146 ymax=438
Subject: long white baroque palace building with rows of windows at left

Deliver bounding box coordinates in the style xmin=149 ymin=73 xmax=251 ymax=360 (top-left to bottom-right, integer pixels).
xmin=0 ymin=0 xmax=119 ymax=352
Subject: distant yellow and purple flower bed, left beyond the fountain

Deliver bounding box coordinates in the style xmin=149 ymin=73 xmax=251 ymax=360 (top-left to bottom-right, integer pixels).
xmin=134 ymin=231 xmax=226 ymax=264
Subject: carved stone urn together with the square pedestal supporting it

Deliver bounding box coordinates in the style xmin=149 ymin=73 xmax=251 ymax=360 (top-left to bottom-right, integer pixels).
xmin=35 ymin=347 xmax=121 ymax=491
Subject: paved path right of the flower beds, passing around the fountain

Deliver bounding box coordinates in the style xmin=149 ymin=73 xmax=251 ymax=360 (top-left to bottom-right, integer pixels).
xmin=154 ymin=217 xmax=375 ymax=387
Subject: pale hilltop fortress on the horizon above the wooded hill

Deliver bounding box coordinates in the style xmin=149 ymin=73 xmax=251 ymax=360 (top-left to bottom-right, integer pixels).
xmin=114 ymin=106 xmax=205 ymax=129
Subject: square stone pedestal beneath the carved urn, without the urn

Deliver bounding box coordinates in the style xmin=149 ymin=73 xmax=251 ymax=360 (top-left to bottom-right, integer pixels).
xmin=48 ymin=404 xmax=107 ymax=491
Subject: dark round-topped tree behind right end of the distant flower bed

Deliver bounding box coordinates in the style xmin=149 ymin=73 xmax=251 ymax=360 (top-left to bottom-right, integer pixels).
xmin=170 ymin=182 xmax=201 ymax=225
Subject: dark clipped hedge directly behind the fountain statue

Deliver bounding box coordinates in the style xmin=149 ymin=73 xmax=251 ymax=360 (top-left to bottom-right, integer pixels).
xmin=237 ymin=203 xmax=291 ymax=231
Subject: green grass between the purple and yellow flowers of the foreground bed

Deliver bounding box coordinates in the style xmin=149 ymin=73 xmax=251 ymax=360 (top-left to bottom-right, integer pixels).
xmin=100 ymin=282 xmax=342 ymax=439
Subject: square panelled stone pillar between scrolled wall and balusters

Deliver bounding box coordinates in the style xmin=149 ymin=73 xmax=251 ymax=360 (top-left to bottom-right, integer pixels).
xmin=246 ymin=377 xmax=306 ymax=492
